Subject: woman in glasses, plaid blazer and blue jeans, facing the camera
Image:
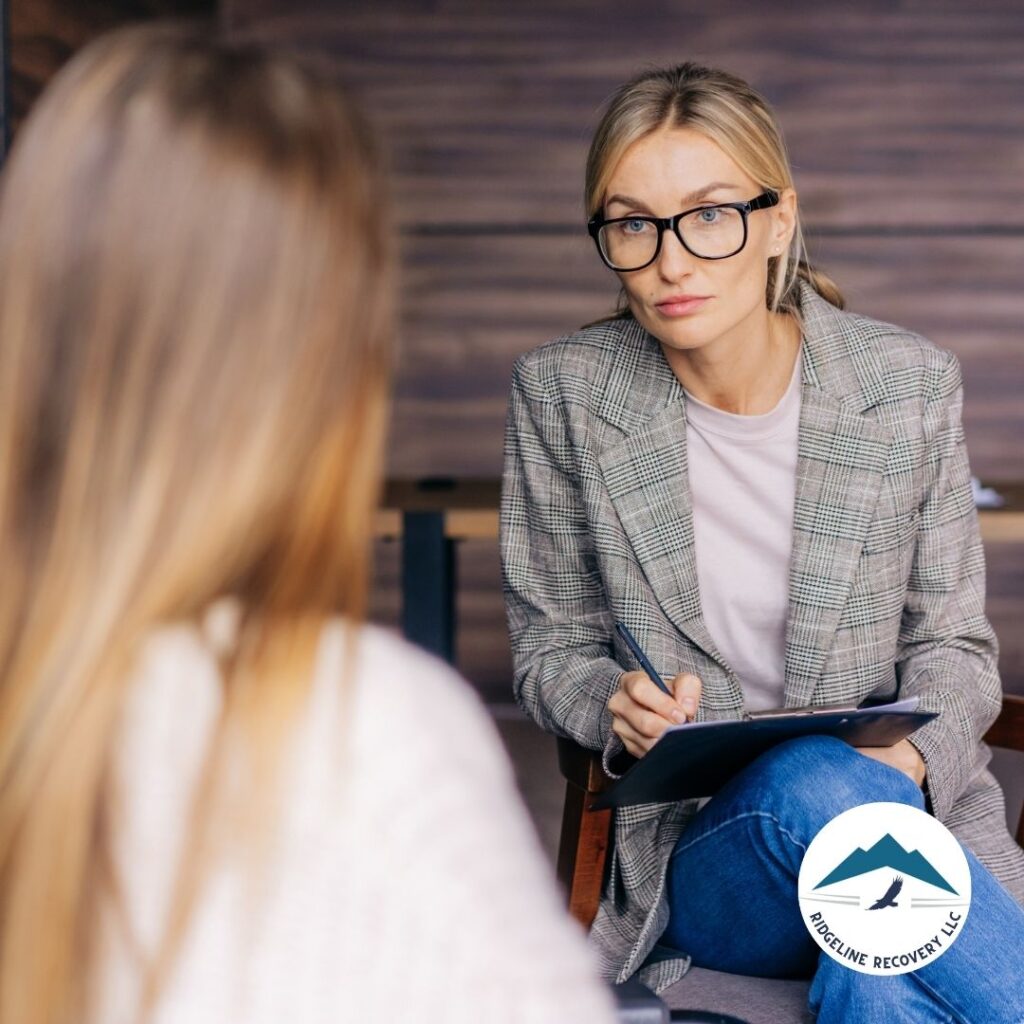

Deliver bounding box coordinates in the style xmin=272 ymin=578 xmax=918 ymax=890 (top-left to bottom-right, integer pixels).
xmin=502 ymin=63 xmax=1024 ymax=1021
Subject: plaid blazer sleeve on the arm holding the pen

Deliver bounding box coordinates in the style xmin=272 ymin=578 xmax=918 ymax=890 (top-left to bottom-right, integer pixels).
xmin=500 ymin=354 xmax=624 ymax=756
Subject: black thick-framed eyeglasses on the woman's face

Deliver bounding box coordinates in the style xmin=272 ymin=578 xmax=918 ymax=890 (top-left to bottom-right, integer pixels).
xmin=587 ymin=189 xmax=778 ymax=272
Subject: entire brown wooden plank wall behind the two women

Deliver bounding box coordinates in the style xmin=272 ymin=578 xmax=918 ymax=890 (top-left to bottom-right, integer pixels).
xmin=12 ymin=0 xmax=1024 ymax=700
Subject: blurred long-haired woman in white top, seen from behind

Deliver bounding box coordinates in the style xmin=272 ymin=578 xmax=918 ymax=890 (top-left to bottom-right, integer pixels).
xmin=0 ymin=28 xmax=607 ymax=1024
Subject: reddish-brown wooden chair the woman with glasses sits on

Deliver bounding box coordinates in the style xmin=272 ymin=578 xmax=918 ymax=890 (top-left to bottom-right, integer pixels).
xmin=558 ymin=694 xmax=1024 ymax=1003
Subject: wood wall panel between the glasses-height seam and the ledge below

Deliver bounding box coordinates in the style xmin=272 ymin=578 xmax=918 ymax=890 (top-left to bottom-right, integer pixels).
xmin=388 ymin=236 xmax=1024 ymax=480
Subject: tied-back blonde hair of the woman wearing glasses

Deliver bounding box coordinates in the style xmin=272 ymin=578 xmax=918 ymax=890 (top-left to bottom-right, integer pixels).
xmin=584 ymin=61 xmax=845 ymax=315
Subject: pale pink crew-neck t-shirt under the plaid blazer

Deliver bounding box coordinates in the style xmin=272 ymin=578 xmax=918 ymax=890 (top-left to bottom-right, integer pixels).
xmin=686 ymin=355 xmax=801 ymax=709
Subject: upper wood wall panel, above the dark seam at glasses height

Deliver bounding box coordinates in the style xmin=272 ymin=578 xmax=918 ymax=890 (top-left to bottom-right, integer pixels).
xmin=223 ymin=0 xmax=1024 ymax=231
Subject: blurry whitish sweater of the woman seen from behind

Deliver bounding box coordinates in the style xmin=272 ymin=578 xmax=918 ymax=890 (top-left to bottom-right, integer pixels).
xmin=90 ymin=616 xmax=613 ymax=1024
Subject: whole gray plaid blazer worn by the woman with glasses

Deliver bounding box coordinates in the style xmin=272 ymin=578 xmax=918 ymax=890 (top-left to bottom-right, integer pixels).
xmin=501 ymin=283 xmax=1024 ymax=990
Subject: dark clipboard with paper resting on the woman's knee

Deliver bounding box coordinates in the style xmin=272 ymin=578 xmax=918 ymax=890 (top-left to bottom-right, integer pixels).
xmin=590 ymin=696 xmax=938 ymax=811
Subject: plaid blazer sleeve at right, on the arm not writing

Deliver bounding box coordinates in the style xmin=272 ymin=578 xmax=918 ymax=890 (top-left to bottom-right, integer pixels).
xmin=896 ymin=353 xmax=1001 ymax=820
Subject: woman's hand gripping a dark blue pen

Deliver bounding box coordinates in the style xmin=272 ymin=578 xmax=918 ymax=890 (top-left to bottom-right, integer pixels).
xmin=608 ymin=623 xmax=700 ymax=758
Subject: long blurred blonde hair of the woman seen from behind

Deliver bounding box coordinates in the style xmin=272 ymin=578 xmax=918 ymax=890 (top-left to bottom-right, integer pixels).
xmin=0 ymin=26 xmax=393 ymax=1024
